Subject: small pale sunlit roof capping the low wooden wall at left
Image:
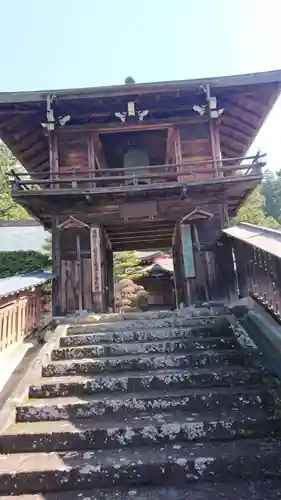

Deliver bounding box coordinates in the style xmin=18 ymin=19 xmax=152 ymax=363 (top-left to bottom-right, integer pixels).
xmin=0 ymin=271 xmax=56 ymax=298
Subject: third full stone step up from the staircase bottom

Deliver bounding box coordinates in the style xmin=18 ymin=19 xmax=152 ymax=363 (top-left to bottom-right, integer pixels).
xmin=16 ymin=386 xmax=274 ymax=422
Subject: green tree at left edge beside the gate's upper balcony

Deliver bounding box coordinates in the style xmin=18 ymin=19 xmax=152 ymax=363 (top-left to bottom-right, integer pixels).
xmin=0 ymin=141 xmax=30 ymax=220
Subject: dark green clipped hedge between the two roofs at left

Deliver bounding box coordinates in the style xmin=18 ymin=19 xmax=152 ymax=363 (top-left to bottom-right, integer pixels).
xmin=0 ymin=251 xmax=51 ymax=278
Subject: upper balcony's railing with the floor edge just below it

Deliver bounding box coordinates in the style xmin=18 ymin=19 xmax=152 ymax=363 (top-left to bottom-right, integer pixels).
xmin=11 ymin=154 xmax=266 ymax=200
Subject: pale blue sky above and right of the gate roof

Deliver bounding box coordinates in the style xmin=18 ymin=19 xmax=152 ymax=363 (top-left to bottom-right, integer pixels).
xmin=0 ymin=0 xmax=281 ymax=170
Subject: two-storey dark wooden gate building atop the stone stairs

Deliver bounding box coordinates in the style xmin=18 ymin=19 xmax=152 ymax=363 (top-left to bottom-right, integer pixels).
xmin=0 ymin=71 xmax=281 ymax=315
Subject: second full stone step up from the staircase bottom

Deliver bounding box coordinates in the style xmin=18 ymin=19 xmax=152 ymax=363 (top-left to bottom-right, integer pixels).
xmin=0 ymin=409 xmax=281 ymax=454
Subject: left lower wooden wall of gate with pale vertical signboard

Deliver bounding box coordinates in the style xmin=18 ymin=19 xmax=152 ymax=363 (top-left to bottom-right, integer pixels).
xmin=53 ymin=226 xmax=114 ymax=315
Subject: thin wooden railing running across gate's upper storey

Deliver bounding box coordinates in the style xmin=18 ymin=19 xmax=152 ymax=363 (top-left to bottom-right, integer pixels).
xmin=11 ymin=154 xmax=265 ymax=192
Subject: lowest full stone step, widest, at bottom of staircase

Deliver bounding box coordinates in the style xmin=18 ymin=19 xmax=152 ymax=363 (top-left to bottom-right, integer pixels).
xmin=0 ymin=439 xmax=281 ymax=498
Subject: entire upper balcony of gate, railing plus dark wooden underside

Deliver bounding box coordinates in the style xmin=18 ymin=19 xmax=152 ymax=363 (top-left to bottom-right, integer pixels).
xmin=8 ymin=155 xmax=265 ymax=229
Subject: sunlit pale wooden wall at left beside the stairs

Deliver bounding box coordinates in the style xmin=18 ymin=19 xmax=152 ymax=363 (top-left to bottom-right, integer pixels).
xmin=0 ymin=287 xmax=42 ymax=351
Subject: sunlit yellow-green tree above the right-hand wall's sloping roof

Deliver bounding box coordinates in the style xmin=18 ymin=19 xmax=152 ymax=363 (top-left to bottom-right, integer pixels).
xmin=232 ymin=188 xmax=278 ymax=227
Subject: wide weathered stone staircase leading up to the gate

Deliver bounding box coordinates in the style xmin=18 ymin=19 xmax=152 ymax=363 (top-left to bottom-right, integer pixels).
xmin=0 ymin=313 xmax=281 ymax=500
